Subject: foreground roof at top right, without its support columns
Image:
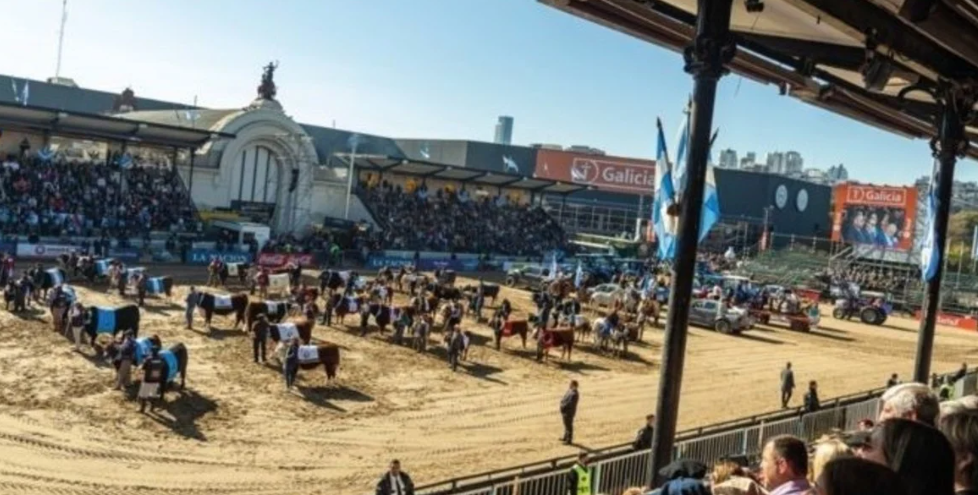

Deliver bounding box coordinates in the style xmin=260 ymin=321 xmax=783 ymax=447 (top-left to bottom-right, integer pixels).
xmin=540 ymin=0 xmax=978 ymax=158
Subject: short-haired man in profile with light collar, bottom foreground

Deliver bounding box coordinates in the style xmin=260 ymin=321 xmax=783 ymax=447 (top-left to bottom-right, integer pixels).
xmin=761 ymin=435 xmax=811 ymax=495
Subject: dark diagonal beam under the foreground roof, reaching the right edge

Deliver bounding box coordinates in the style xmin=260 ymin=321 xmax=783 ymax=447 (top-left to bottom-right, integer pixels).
xmin=784 ymin=0 xmax=978 ymax=80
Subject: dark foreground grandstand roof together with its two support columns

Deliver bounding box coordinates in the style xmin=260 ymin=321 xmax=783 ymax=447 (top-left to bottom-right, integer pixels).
xmin=539 ymin=0 xmax=978 ymax=482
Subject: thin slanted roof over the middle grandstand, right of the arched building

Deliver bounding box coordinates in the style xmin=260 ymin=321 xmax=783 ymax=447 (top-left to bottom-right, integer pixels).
xmin=333 ymin=153 xmax=588 ymax=194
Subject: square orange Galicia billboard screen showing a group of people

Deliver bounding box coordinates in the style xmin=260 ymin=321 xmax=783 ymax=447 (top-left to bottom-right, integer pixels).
xmin=832 ymin=184 xmax=917 ymax=251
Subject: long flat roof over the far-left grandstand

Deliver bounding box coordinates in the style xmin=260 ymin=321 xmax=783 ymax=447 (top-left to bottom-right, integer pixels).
xmin=0 ymin=102 xmax=235 ymax=148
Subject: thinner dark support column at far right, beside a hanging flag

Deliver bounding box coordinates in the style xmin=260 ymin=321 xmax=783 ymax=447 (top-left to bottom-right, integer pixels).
xmin=912 ymin=82 xmax=975 ymax=383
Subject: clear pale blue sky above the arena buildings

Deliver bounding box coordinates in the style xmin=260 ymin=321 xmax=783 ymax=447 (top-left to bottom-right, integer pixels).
xmin=0 ymin=0 xmax=978 ymax=184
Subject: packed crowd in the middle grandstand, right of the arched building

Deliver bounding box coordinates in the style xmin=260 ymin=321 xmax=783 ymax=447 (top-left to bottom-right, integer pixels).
xmin=360 ymin=181 xmax=568 ymax=256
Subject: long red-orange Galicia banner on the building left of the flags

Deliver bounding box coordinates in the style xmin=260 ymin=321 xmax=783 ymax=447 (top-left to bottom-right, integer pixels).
xmin=536 ymin=149 xmax=655 ymax=195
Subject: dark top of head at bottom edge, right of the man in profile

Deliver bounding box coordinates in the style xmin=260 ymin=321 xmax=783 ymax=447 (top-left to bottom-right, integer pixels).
xmin=814 ymin=457 xmax=907 ymax=495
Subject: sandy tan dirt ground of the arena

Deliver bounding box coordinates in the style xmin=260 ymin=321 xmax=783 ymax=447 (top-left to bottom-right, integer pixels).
xmin=0 ymin=270 xmax=978 ymax=495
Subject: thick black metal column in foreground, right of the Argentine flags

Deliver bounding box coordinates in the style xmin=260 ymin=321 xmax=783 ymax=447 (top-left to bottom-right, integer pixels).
xmin=649 ymin=0 xmax=736 ymax=486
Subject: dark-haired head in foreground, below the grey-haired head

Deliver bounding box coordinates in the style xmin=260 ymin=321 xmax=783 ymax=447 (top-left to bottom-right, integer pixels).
xmin=862 ymin=418 xmax=955 ymax=495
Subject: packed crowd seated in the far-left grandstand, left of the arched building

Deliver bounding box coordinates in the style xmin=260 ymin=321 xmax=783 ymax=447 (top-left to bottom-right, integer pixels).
xmin=0 ymin=155 xmax=196 ymax=239
